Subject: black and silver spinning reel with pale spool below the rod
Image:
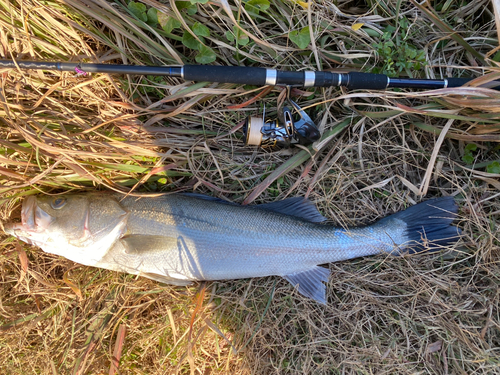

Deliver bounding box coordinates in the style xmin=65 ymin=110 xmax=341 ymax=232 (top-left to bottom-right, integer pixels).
xmin=243 ymin=98 xmax=321 ymax=148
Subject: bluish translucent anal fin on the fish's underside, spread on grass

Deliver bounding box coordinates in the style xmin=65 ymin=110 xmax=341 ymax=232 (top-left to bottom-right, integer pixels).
xmin=284 ymin=266 xmax=330 ymax=305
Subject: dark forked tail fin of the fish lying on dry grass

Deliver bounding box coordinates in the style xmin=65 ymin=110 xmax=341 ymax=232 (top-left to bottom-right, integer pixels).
xmin=381 ymin=197 xmax=461 ymax=254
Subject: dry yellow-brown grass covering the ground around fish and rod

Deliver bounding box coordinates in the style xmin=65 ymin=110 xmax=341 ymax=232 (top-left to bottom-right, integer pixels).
xmin=0 ymin=0 xmax=500 ymax=374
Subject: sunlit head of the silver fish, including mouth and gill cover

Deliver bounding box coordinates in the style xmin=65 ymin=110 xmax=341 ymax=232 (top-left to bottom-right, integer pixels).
xmin=4 ymin=194 xmax=128 ymax=265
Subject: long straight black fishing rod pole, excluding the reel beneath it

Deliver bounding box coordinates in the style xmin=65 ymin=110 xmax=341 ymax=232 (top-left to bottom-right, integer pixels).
xmin=0 ymin=60 xmax=494 ymax=90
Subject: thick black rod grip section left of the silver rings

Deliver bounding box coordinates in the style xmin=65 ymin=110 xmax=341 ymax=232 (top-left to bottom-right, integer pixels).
xmin=184 ymin=65 xmax=266 ymax=86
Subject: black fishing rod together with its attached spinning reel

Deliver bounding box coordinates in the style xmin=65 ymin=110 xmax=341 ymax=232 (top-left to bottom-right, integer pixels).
xmin=0 ymin=60 xmax=500 ymax=148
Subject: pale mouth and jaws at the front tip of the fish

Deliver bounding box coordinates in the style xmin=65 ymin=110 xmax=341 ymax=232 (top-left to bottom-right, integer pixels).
xmin=4 ymin=196 xmax=54 ymax=244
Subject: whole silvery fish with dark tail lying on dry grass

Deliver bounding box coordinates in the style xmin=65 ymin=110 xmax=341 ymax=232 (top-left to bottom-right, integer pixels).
xmin=4 ymin=191 xmax=461 ymax=304
